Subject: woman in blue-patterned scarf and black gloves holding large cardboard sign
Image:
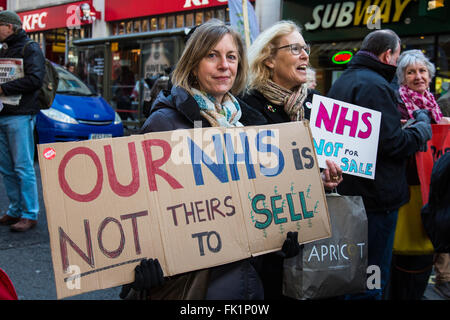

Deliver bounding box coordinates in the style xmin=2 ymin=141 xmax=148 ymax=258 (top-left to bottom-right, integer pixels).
xmin=121 ymin=20 xmax=299 ymax=300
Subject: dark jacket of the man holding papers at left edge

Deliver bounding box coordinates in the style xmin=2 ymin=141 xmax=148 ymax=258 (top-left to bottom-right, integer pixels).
xmin=0 ymin=29 xmax=45 ymax=115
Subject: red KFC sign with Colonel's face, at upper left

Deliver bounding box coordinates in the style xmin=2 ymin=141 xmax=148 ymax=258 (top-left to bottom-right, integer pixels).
xmin=17 ymin=0 xmax=100 ymax=32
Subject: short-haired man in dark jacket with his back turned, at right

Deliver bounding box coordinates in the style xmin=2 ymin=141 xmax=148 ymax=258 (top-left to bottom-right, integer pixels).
xmin=328 ymin=30 xmax=431 ymax=299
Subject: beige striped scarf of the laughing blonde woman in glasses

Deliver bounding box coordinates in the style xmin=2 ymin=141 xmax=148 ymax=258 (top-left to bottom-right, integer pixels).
xmin=258 ymin=80 xmax=308 ymax=121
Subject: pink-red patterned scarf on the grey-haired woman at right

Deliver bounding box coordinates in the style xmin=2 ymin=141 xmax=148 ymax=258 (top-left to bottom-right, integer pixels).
xmin=399 ymin=85 xmax=443 ymax=123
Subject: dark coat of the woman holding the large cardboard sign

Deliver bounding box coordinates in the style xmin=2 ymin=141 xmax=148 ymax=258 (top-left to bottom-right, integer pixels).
xmin=141 ymin=87 xmax=267 ymax=300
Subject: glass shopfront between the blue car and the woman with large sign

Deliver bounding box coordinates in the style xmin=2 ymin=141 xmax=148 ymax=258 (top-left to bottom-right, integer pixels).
xmin=75 ymin=34 xmax=184 ymax=132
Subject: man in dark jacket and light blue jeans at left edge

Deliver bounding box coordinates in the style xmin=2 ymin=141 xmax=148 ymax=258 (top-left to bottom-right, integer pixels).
xmin=0 ymin=10 xmax=45 ymax=232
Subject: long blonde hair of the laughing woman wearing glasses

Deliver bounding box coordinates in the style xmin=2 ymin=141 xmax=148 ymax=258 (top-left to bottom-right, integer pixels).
xmin=248 ymin=20 xmax=301 ymax=90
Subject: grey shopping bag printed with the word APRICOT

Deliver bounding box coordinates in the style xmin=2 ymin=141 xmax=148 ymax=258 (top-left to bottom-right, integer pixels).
xmin=283 ymin=193 xmax=368 ymax=300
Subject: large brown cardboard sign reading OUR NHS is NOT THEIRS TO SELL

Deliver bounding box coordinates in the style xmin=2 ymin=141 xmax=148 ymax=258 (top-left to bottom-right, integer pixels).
xmin=38 ymin=122 xmax=331 ymax=298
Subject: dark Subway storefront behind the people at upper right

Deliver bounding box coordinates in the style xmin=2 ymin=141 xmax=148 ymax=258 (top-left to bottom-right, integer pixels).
xmin=282 ymin=0 xmax=450 ymax=96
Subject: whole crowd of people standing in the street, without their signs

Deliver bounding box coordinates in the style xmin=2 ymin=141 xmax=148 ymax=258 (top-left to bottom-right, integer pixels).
xmin=0 ymin=11 xmax=450 ymax=300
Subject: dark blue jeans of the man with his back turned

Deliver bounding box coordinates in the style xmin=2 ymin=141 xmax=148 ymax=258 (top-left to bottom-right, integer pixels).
xmin=345 ymin=209 xmax=398 ymax=300
